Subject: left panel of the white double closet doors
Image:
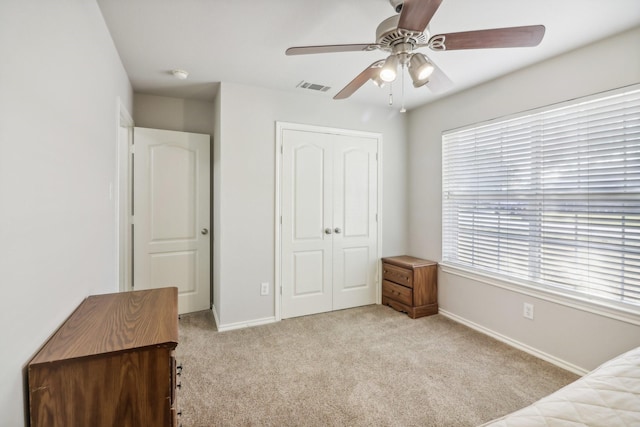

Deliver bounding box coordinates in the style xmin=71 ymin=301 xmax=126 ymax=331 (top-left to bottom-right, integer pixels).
xmin=281 ymin=130 xmax=333 ymax=318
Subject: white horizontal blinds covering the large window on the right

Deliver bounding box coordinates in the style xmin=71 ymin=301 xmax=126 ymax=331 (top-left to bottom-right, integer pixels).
xmin=442 ymin=86 xmax=640 ymax=312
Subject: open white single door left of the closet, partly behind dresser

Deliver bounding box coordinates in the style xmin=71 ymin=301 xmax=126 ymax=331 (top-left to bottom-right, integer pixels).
xmin=132 ymin=128 xmax=210 ymax=313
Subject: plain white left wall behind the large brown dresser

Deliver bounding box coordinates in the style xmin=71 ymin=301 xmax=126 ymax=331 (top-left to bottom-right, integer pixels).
xmin=0 ymin=0 xmax=132 ymax=427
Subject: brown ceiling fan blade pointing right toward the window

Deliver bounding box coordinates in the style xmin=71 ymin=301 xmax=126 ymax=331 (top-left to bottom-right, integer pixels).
xmin=429 ymin=25 xmax=545 ymax=50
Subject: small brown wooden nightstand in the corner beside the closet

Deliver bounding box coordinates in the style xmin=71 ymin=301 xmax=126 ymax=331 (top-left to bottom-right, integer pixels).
xmin=382 ymin=255 xmax=438 ymax=319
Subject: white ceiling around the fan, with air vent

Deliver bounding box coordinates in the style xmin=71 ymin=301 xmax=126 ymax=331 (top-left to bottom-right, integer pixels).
xmin=98 ymin=0 xmax=640 ymax=112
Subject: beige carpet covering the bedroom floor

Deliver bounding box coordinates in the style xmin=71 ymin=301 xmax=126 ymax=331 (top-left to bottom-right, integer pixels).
xmin=177 ymin=305 xmax=577 ymax=427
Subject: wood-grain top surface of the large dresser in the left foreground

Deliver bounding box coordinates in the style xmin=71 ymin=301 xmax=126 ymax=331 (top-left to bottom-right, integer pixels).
xmin=31 ymin=287 xmax=178 ymax=364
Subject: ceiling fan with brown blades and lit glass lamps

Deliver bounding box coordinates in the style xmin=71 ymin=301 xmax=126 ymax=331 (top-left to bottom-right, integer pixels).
xmin=286 ymin=0 xmax=545 ymax=99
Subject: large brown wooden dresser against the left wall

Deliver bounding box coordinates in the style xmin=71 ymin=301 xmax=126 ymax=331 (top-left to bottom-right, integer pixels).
xmin=27 ymin=288 xmax=178 ymax=427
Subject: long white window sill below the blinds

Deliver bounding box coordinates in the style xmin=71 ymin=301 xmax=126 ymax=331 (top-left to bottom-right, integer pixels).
xmin=440 ymin=262 xmax=640 ymax=326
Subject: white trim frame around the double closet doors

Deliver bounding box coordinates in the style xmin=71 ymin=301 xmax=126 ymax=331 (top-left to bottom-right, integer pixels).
xmin=273 ymin=121 xmax=382 ymax=322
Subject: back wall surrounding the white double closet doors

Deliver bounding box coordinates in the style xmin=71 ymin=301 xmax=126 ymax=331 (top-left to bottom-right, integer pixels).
xmin=214 ymin=83 xmax=407 ymax=327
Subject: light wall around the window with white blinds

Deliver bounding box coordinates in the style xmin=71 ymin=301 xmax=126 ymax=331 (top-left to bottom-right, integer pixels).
xmin=409 ymin=28 xmax=640 ymax=371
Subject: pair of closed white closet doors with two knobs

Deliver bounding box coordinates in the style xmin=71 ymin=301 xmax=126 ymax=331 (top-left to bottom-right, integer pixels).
xmin=281 ymin=129 xmax=378 ymax=318
